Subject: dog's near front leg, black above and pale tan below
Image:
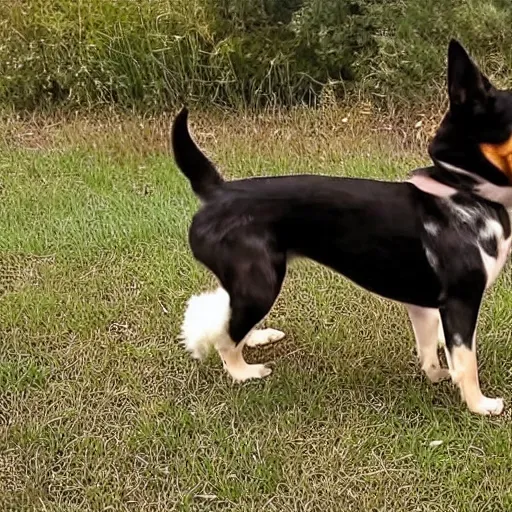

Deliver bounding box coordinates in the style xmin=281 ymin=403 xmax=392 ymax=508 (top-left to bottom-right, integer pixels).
xmin=440 ymin=293 xmax=503 ymax=415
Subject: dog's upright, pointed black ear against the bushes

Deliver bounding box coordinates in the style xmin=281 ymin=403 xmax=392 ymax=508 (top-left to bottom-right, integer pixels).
xmin=448 ymin=39 xmax=493 ymax=107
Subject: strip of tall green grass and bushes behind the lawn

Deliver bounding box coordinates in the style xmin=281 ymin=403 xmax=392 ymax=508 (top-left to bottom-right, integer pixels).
xmin=0 ymin=0 xmax=512 ymax=111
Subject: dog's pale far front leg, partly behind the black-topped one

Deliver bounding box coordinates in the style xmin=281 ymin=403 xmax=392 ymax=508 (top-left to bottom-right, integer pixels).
xmin=407 ymin=305 xmax=450 ymax=383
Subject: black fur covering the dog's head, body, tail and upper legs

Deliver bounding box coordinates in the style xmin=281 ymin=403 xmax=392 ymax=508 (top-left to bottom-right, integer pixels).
xmin=172 ymin=41 xmax=512 ymax=380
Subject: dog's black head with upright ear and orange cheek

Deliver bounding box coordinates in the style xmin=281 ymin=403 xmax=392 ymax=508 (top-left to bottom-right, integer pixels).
xmin=429 ymin=40 xmax=512 ymax=187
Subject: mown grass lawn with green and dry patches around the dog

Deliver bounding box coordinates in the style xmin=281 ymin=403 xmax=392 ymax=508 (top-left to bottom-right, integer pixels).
xmin=0 ymin=113 xmax=512 ymax=512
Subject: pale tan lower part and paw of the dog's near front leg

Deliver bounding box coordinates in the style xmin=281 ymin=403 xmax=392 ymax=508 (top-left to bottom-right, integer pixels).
xmin=450 ymin=338 xmax=503 ymax=416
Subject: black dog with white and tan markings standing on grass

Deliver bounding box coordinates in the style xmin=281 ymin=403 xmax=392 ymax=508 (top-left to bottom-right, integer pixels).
xmin=172 ymin=41 xmax=512 ymax=414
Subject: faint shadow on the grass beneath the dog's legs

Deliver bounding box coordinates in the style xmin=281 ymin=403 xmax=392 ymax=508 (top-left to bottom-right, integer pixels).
xmin=180 ymin=325 xmax=510 ymax=425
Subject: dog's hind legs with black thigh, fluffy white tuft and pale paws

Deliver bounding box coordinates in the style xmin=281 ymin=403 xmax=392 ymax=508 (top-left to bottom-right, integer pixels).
xmin=181 ymin=243 xmax=286 ymax=381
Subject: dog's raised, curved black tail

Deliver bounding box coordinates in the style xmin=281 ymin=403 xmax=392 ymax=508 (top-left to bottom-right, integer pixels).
xmin=171 ymin=107 xmax=224 ymax=201
